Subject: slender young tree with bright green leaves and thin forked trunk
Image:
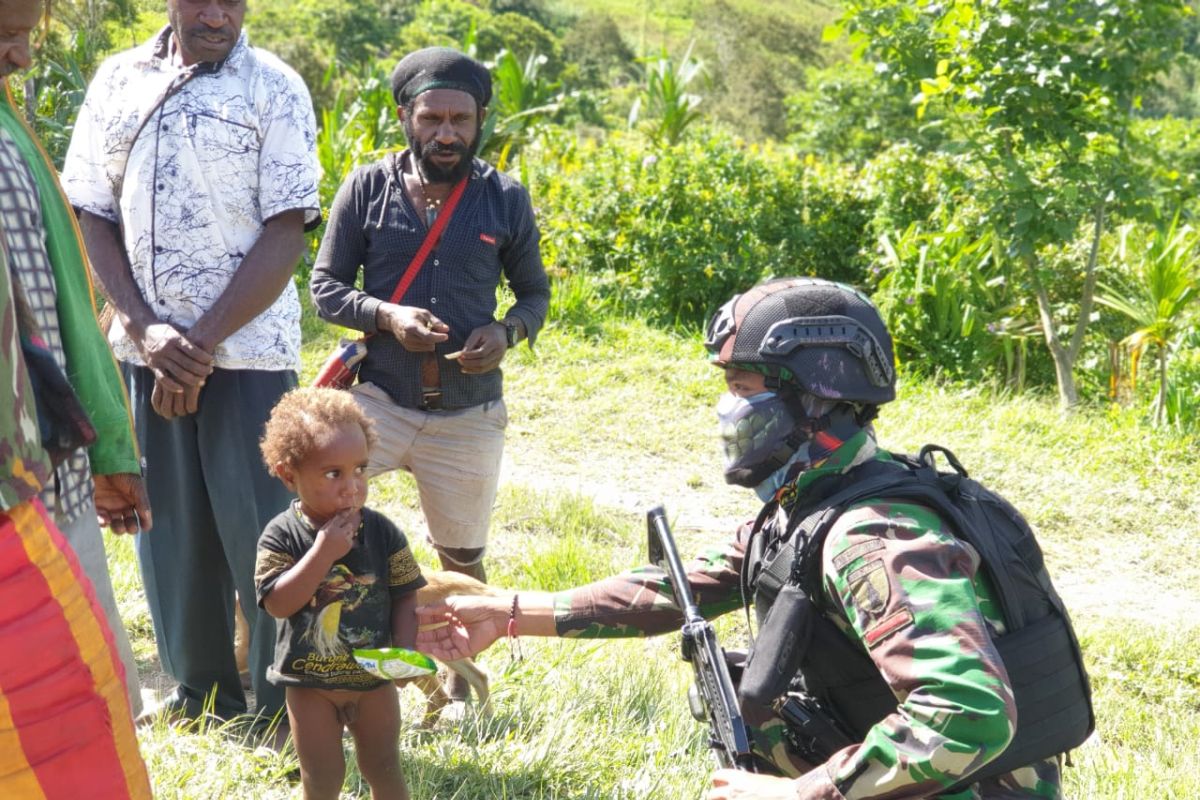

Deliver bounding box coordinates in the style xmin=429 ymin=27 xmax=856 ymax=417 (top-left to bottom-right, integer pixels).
xmin=841 ymin=0 xmax=1190 ymax=405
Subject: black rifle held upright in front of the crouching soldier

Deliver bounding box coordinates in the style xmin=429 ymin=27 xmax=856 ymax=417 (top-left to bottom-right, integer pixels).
xmin=646 ymin=506 xmax=756 ymax=771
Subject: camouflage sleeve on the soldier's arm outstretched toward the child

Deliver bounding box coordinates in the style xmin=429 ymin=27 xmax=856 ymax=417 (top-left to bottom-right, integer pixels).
xmin=554 ymin=523 xmax=750 ymax=638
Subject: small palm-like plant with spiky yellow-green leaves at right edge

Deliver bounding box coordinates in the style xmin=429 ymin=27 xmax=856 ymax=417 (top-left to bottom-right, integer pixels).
xmin=1097 ymin=213 xmax=1200 ymax=425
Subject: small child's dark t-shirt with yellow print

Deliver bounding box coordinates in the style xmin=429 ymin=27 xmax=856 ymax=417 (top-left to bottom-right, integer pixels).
xmin=254 ymin=503 xmax=425 ymax=691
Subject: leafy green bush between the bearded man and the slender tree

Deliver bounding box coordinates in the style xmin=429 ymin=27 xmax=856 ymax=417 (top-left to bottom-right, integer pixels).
xmin=530 ymin=134 xmax=870 ymax=325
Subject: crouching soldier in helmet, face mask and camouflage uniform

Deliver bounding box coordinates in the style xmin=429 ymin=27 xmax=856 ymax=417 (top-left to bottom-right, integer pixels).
xmin=418 ymin=278 xmax=1061 ymax=800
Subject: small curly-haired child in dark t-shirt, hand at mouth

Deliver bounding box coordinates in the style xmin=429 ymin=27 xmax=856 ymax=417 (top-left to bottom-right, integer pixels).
xmin=254 ymin=387 xmax=425 ymax=800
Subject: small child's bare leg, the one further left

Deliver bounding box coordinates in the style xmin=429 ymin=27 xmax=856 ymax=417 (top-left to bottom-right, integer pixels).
xmin=287 ymin=686 xmax=346 ymax=800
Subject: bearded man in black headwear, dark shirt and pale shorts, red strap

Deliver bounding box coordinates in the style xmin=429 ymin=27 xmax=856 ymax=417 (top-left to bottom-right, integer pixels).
xmin=311 ymin=48 xmax=550 ymax=696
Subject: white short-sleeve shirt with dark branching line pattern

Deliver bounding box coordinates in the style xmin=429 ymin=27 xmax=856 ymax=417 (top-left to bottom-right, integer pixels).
xmin=62 ymin=28 xmax=320 ymax=369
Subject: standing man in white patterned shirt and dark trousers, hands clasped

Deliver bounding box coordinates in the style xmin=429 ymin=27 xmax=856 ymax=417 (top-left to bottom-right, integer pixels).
xmin=62 ymin=0 xmax=320 ymax=717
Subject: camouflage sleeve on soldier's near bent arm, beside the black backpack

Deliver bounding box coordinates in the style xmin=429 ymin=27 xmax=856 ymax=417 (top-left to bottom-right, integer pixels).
xmin=797 ymin=503 xmax=1016 ymax=800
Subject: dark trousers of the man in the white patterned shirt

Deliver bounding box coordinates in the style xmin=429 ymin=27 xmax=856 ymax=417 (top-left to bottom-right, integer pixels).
xmin=125 ymin=365 xmax=296 ymax=718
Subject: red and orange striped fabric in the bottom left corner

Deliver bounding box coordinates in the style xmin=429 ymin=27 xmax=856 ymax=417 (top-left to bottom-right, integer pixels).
xmin=0 ymin=500 xmax=151 ymax=800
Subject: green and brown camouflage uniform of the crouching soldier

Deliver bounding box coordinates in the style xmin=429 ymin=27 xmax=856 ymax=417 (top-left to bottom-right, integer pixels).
xmin=554 ymin=429 xmax=1061 ymax=800
